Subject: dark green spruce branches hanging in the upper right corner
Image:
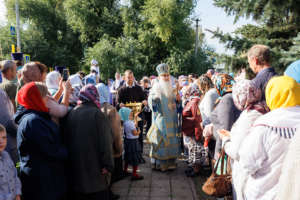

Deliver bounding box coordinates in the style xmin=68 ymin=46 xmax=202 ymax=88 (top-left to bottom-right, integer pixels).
xmin=211 ymin=0 xmax=300 ymax=73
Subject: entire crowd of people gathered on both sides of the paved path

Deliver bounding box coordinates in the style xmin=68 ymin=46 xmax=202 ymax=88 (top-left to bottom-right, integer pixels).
xmin=0 ymin=45 xmax=300 ymax=200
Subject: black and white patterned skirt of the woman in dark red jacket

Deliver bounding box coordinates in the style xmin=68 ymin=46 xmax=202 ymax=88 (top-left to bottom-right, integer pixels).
xmin=183 ymin=135 xmax=208 ymax=166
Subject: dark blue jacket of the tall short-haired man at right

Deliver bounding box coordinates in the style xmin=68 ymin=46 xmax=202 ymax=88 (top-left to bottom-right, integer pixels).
xmin=252 ymin=67 xmax=277 ymax=101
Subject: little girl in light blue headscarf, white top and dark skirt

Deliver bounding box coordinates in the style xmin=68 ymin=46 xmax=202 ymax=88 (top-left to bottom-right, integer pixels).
xmin=119 ymin=107 xmax=144 ymax=181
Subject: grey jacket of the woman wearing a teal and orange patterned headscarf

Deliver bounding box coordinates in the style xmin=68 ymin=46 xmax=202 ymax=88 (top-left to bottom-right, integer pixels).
xmin=211 ymin=93 xmax=241 ymax=159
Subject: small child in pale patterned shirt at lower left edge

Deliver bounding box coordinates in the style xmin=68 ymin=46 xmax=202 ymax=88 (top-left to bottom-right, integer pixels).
xmin=0 ymin=124 xmax=21 ymax=200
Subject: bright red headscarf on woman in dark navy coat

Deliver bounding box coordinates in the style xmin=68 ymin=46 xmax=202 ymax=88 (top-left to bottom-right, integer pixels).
xmin=18 ymin=82 xmax=49 ymax=112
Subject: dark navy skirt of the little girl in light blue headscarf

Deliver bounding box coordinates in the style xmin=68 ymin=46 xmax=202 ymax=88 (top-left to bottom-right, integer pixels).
xmin=124 ymin=138 xmax=142 ymax=166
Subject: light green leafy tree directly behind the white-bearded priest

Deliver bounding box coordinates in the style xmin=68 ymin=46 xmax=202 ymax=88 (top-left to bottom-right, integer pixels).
xmin=86 ymin=0 xmax=212 ymax=79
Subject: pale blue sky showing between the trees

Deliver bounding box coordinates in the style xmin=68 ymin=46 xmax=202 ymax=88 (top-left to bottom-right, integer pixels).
xmin=0 ymin=0 xmax=255 ymax=53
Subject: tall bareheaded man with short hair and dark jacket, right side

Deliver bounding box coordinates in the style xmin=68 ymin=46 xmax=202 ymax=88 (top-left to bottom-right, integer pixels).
xmin=247 ymin=44 xmax=277 ymax=100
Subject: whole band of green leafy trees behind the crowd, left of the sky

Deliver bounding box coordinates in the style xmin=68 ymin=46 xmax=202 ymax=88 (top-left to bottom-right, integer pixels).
xmin=0 ymin=0 xmax=212 ymax=79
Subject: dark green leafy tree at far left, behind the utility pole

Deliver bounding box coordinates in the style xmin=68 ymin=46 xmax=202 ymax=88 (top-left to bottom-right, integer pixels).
xmin=6 ymin=0 xmax=83 ymax=72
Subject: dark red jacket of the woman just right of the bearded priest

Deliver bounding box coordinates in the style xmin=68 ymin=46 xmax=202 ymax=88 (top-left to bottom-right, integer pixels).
xmin=182 ymin=98 xmax=203 ymax=141
